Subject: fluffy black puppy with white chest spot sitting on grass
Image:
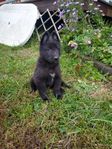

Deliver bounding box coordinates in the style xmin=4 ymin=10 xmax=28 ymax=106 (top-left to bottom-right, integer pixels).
xmin=31 ymin=32 xmax=68 ymax=100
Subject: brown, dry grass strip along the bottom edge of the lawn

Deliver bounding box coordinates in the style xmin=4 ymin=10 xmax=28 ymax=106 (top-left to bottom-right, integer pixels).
xmin=1 ymin=125 xmax=110 ymax=149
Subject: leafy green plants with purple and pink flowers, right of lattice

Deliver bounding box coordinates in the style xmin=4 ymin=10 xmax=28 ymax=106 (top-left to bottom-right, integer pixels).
xmin=58 ymin=0 xmax=112 ymax=66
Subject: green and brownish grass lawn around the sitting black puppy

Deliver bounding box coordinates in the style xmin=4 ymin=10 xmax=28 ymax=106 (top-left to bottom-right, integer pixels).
xmin=0 ymin=35 xmax=112 ymax=149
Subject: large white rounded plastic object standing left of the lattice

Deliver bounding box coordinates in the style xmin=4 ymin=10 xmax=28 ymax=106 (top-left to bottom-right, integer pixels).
xmin=0 ymin=4 xmax=40 ymax=46
